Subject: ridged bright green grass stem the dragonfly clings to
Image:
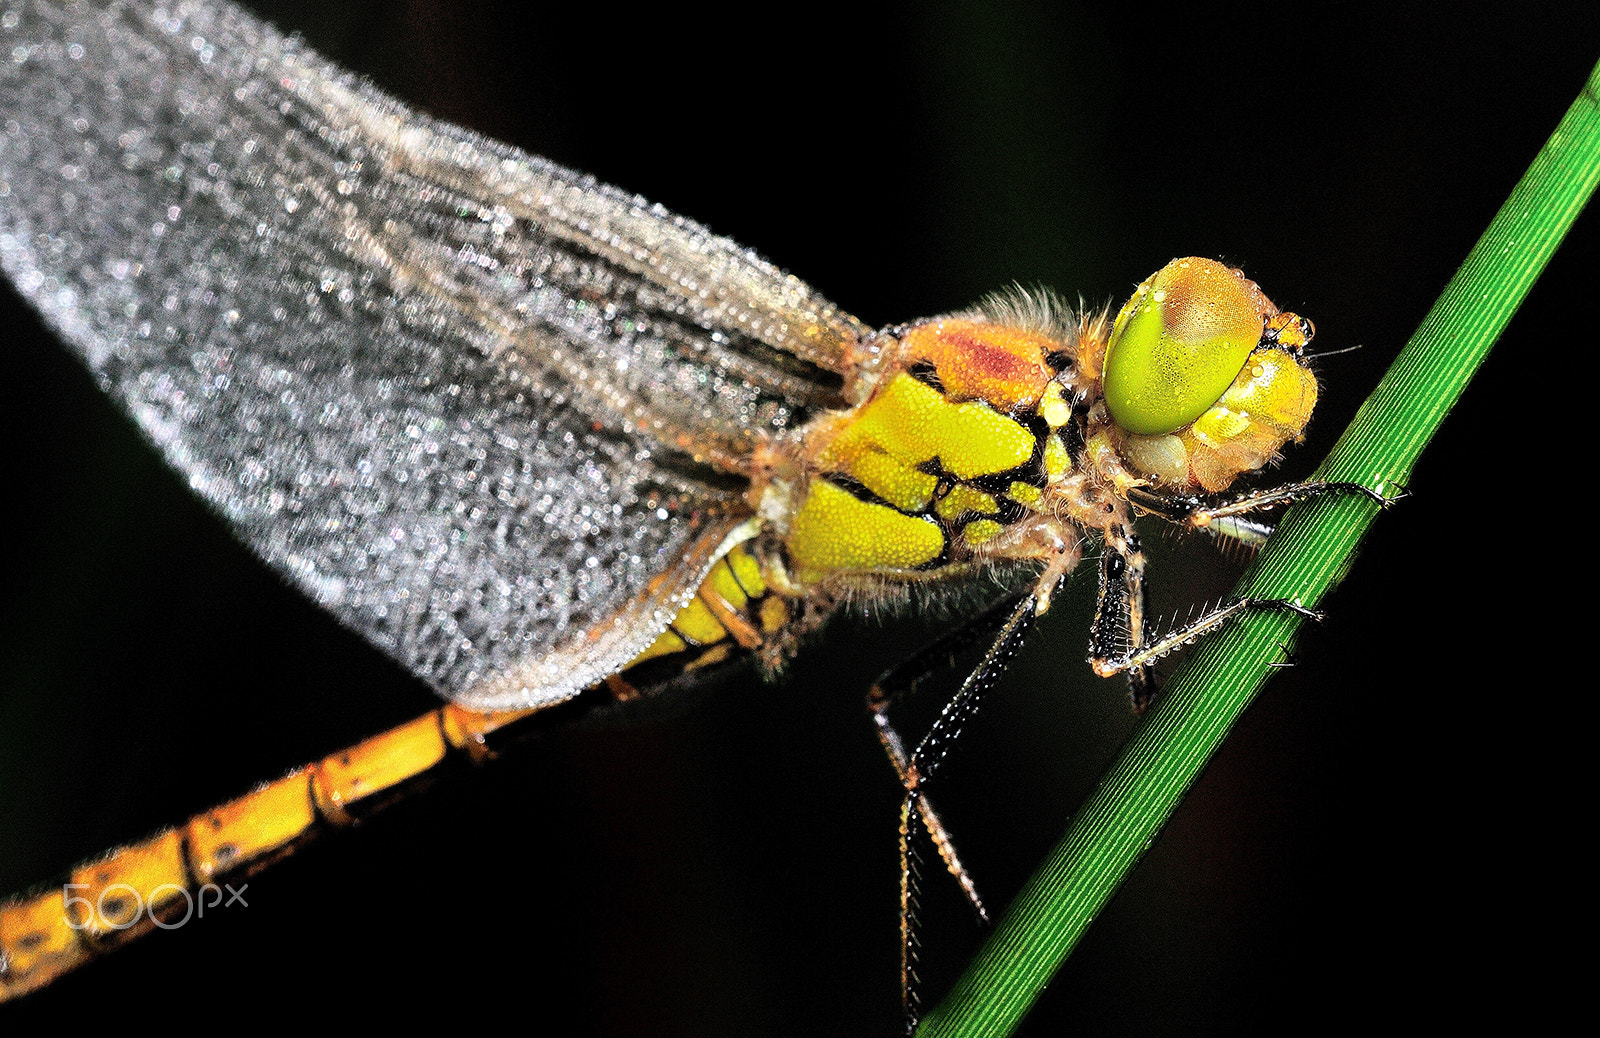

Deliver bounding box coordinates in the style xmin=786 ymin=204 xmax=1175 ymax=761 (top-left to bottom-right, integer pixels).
xmin=918 ymin=58 xmax=1600 ymax=1038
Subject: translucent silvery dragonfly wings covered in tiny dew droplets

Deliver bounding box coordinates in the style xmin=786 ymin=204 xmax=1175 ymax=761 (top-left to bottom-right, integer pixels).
xmin=0 ymin=3 xmax=864 ymax=707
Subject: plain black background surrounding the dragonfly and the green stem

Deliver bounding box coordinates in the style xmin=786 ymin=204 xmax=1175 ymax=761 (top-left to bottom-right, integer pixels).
xmin=0 ymin=2 xmax=1600 ymax=1035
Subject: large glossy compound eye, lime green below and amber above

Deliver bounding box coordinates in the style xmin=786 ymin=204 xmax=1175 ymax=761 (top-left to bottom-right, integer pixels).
xmin=1102 ymin=256 xmax=1274 ymax=435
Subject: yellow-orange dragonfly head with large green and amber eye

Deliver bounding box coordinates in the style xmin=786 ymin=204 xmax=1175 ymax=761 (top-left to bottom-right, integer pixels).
xmin=1101 ymin=258 xmax=1317 ymax=493
